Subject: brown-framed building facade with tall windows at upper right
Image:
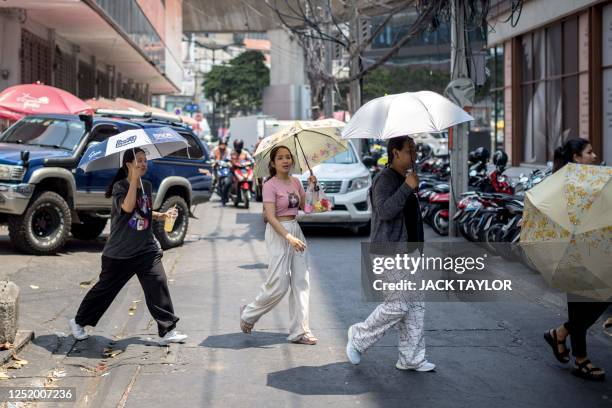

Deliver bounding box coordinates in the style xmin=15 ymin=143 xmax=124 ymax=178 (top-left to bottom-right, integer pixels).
xmin=488 ymin=0 xmax=612 ymax=166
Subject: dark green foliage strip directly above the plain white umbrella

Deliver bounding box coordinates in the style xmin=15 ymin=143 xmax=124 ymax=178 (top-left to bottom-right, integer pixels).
xmin=363 ymin=67 xmax=450 ymax=103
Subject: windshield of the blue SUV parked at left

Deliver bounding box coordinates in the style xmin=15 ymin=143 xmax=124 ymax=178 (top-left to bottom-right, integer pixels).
xmin=0 ymin=116 xmax=85 ymax=150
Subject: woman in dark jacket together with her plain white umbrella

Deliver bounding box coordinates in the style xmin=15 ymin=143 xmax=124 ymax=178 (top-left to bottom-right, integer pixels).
xmin=342 ymin=91 xmax=473 ymax=371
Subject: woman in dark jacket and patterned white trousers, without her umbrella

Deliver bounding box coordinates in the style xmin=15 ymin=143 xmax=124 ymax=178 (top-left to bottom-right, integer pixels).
xmin=346 ymin=136 xmax=435 ymax=371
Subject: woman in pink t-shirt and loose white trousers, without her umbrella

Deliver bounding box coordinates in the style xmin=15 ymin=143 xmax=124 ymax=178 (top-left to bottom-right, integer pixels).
xmin=240 ymin=146 xmax=317 ymax=345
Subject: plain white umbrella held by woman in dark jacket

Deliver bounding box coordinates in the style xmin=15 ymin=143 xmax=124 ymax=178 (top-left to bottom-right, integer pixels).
xmin=342 ymin=91 xmax=474 ymax=139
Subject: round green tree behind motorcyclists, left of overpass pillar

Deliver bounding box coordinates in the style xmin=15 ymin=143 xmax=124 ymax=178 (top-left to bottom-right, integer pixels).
xmin=203 ymin=51 xmax=270 ymax=115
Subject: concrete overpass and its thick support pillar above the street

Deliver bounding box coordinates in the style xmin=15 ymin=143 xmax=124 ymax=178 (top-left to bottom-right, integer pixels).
xmin=183 ymin=0 xmax=405 ymax=119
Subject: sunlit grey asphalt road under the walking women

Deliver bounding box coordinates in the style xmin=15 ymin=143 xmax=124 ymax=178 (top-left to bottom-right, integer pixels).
xmin=0 ymin=202 xmax=612 ymax=407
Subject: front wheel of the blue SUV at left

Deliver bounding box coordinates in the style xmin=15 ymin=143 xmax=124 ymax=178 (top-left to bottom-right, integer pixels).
xmin=8 ymin=191 xmax=72 ymax=255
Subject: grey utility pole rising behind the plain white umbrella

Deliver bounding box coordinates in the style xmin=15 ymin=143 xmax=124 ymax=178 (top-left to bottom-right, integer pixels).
xmin=447 ymin=0 xmax=471 ymax=238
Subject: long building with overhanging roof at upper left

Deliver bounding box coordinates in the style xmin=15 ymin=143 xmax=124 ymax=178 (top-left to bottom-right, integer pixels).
xmin=0 ymin=0 xmax=183 ymax=104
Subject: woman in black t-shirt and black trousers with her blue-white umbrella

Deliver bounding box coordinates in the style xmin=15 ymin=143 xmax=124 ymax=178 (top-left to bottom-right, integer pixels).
xmin=69 ymin=128 xmax=187 ymax=345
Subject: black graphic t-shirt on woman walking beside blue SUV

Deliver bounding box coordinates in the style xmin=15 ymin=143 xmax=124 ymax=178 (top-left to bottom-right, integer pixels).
xmin=102 ymin=179 xmax=161 ymax=259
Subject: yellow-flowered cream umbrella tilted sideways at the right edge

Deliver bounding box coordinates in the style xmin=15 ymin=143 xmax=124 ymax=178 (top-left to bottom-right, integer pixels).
xmin=520 ymin=163 xmax=612 ymax=300
